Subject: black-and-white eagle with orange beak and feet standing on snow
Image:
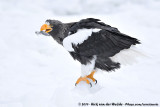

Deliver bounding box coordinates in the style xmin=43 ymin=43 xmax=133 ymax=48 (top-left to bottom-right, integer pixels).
xmin=37 ymin=18 xmax=140 ymax=87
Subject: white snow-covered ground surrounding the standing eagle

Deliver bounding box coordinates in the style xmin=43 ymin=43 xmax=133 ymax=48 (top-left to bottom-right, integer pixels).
xmin=0 ymin=0 xmax=160 ymax=107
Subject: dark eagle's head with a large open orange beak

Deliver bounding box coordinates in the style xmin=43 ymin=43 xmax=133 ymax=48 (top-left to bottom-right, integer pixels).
xmin=40 ymin=19 xmax=64 ymax=44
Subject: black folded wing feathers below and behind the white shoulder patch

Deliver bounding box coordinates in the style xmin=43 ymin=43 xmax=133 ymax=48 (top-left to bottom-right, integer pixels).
xmin=76 ymin=30 xmax=140 ymax=57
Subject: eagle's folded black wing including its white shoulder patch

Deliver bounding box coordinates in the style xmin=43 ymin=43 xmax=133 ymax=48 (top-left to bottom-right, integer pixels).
xmin=63 ymin=18 xmax=140 ymax=57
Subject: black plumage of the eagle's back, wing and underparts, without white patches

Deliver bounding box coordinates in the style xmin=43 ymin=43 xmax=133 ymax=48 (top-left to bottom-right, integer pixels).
xmin=46 ymin=18 xmax=140 ymax=71
